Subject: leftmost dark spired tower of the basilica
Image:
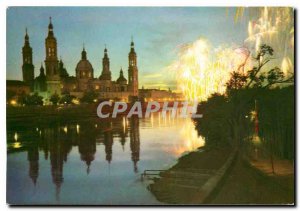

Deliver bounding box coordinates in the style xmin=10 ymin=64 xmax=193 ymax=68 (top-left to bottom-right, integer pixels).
xmin=22 ymin=28 xmax=34 ymax=91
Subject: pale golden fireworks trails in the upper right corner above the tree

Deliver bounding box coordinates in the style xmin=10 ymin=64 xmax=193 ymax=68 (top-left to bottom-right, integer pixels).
xmin=245 ymin=7 xmax=294 ymax=77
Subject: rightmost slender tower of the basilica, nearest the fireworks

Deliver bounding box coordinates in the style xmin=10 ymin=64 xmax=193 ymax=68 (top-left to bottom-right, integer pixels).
xmin=128 ymin=40 xmax=139 ymax=97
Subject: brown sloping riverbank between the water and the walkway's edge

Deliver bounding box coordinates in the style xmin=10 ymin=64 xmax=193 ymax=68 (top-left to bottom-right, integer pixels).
xmin=149 ymin=146 xmax=236 ymax=204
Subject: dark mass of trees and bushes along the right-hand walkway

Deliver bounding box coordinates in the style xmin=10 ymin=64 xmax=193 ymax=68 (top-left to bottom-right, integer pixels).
xmin=196 ymin=44 xmax=295 ymax=159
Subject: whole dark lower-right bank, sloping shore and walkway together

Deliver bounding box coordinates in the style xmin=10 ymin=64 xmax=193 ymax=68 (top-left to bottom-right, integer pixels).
xmin=149 ymin=147 xmax=294 ymax=205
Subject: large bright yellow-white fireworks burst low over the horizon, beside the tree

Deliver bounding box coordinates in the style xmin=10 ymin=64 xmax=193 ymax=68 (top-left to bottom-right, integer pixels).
xmin=170 ymin=39 xmax=249 ymax=101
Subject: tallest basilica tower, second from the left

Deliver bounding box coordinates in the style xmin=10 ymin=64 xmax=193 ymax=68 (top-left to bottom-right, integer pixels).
xmin=45 ymin=17 xmax=61 ymax=95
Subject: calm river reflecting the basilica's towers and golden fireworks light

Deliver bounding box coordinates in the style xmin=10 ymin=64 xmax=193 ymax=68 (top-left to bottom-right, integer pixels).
xmin=7 ymin=113 xmax=205 ymax=205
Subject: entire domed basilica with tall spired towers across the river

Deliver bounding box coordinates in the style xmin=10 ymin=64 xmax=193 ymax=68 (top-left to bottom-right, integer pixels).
xmin=22 ymin=17 xmax=139 ymax=102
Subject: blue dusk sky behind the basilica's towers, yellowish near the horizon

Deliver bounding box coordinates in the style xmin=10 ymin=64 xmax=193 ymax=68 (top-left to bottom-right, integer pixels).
xmin=6 ymin=7 xmax=247 ymax=87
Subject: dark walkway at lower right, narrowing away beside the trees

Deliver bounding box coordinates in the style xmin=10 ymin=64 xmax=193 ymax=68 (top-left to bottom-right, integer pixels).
xmin=209 ymin=156 xmax=294 ymax=205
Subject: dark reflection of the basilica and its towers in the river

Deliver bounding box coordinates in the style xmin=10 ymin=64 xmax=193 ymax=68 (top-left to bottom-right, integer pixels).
xmin=20 ymin=117 xmax=140 ymax=200
